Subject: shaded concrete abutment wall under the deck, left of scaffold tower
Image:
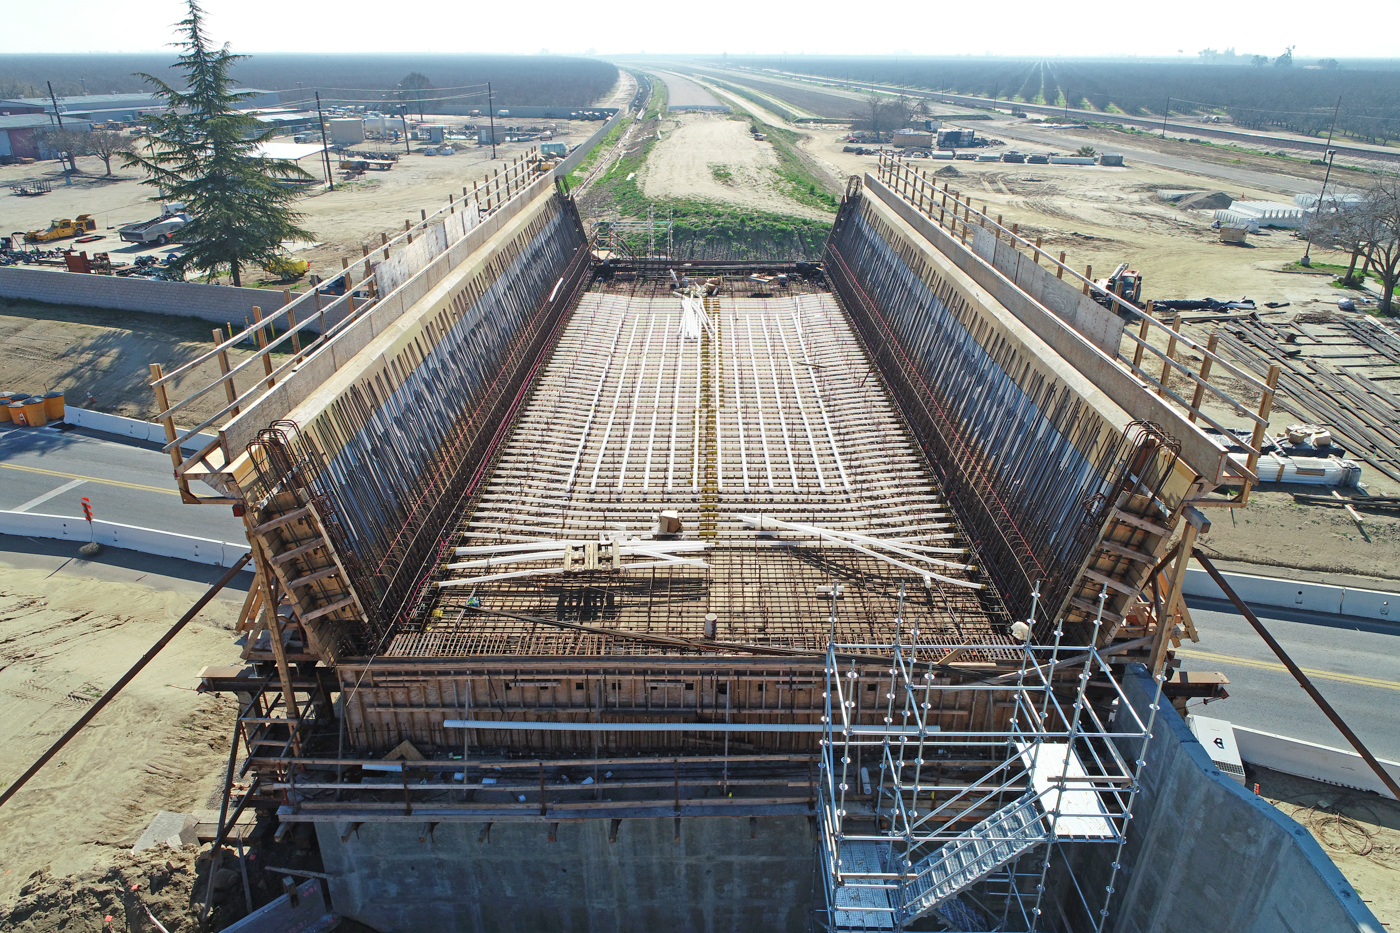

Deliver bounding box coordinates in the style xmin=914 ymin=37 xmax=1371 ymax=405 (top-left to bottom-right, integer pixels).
xmin=316 ymin=817 xmax=816 ymax=933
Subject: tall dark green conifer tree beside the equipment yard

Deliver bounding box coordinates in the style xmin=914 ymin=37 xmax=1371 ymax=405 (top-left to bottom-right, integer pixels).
xmin=125 ymin=0 xmax=312 ymax=286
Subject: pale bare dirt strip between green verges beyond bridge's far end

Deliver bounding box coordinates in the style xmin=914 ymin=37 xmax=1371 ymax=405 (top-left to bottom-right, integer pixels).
xmin=641 ymin=113 xmax=830 ymax=220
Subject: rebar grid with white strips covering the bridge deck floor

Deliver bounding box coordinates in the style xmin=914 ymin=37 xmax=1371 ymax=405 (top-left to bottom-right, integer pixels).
xmin=400 ymin=282 xmax=1009 ymax=657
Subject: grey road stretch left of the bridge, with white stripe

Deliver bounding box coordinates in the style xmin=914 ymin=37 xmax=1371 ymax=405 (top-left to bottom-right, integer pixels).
xmin=0 ymin=424 xmax=244 ymax=542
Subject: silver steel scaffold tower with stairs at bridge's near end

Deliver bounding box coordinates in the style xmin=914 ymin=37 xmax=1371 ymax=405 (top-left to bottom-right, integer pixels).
xmin=818 ymin=594 xmax=1162 ymax=933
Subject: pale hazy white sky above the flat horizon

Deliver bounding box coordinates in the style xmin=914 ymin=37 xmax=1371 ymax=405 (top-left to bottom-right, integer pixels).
xmin=0 ymin=0 xmax=1400 ymax=64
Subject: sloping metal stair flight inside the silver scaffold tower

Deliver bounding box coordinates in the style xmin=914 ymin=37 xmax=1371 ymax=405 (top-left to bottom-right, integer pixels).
xmin=896 ymin=793 xmax=1049 ymax=925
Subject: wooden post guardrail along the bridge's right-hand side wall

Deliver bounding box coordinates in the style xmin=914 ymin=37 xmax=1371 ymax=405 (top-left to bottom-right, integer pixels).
xmin=876 ymin=151 xmax=1281 ymax=504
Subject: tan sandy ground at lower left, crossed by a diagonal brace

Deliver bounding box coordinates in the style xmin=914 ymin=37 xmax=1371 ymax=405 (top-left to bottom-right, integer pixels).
xmin=0 ymin=538 xmax=248 ymax=902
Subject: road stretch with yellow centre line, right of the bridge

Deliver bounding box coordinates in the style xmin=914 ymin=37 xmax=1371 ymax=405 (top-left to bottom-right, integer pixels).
xmin=1180 ymin=600 xmax=1400 ymax=761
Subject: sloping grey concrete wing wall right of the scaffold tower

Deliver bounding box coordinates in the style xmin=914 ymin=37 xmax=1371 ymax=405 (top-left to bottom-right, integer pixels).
xmin=1065 ymin=664 xmax=1382 ymax=933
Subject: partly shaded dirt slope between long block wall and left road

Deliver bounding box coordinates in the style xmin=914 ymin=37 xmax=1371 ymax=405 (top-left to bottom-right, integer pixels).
xmin=0 ymin=298 xmax=284 ymax=427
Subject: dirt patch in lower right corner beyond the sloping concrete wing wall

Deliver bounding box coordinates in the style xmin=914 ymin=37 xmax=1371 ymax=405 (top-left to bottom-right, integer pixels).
xmin=1246 ymin=766 xmax=1400 ymax=929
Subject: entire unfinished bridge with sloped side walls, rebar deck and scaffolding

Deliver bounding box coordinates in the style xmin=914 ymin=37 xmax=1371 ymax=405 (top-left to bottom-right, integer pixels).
xmin=153 ymin=149 xmax=1369 ymax=930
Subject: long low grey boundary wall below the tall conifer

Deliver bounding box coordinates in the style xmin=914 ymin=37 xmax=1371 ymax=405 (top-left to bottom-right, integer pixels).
xmin=0 ymin=266 xmax=281 ymax=331
